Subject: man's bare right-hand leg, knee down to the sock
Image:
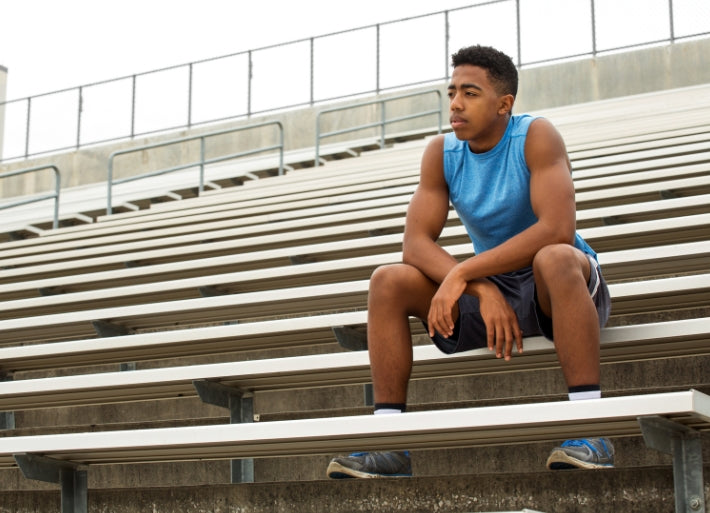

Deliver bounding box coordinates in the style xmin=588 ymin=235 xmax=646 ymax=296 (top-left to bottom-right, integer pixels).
xmin=533 ymin=244 xmax=600 ymax=387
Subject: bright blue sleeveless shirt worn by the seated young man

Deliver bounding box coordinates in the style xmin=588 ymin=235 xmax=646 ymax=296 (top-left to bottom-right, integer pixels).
xmin=444 ymin=115 xmax=596 ymax=259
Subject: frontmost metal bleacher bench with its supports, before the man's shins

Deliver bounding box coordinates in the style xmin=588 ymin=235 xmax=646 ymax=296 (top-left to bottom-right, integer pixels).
xmin=0 ymin=390 xmax=710 ymax=513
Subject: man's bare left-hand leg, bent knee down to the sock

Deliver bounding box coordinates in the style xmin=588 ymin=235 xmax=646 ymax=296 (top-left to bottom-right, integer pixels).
xmin=367 ymin=264 xmax=436 ymax=404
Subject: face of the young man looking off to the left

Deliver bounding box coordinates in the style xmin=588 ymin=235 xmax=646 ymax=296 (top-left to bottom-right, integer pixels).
xmin=448 ymin=64 xmax=513 ymax=151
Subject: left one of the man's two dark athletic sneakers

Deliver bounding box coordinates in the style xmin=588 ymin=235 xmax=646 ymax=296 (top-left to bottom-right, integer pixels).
xmin=328 ymin=451 xmax=412 ymax=479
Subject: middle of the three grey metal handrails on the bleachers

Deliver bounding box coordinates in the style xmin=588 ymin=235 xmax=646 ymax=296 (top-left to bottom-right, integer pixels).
xmin=106 ymin=121 xmax=284 ymax=215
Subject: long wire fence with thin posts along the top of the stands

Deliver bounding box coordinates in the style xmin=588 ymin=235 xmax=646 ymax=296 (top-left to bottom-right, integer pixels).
xmin=0 ymin=0 xmax=710 ymax=160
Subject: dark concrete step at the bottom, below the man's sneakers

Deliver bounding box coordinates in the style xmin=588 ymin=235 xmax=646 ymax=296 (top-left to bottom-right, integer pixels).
xmin=0 ymin=466 xmax=710 ymax=513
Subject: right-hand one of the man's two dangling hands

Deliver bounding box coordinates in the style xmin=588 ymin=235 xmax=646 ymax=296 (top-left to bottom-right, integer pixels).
xmin=478 ymin=283 xmax=523 ymax=361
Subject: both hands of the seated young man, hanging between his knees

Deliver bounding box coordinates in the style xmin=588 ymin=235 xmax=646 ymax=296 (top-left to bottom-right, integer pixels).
xmin=427 ymin=273 xmax=523 ymax=360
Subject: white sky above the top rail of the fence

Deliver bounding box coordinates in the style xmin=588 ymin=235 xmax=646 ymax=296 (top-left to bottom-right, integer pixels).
xmin=0 ymin=0 xmax=480 ymax=100
